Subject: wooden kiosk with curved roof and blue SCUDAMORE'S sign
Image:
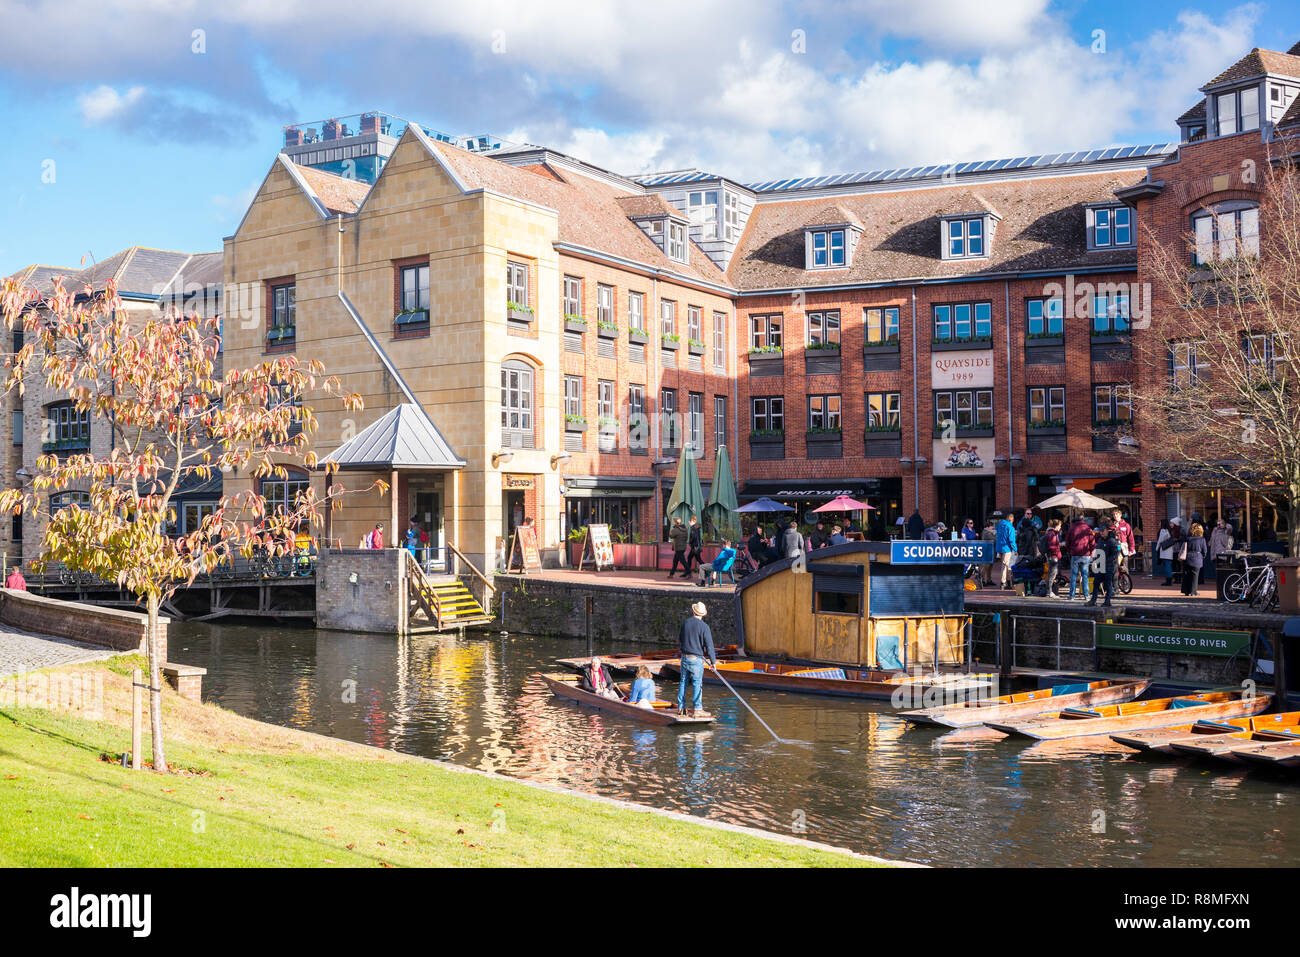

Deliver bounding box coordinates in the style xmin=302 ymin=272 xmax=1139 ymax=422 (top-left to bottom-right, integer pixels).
xmin=736 ymin=541 xmax=993 ymax=670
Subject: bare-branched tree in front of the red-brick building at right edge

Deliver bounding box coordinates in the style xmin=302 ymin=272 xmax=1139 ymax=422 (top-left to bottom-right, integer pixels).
xmin=1132 ymin=146 xmax=1300 ymax=555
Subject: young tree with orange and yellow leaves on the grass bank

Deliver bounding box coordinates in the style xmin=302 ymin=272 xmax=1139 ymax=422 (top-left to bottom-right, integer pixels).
xmin=0 ymin=280 xmax=374 ymax=771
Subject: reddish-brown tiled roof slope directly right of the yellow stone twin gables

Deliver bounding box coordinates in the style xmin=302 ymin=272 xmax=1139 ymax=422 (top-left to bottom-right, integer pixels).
xmin=426 ymin=134 xmax=727 ymax=285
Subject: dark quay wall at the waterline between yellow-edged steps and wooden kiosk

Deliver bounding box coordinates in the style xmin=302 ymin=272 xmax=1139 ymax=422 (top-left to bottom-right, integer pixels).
xmin=495 ymin=575 xmax=736 ymax=648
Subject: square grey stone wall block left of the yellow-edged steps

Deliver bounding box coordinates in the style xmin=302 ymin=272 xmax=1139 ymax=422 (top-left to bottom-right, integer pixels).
xmin=316 ymin=549 xmax=407 ymax=635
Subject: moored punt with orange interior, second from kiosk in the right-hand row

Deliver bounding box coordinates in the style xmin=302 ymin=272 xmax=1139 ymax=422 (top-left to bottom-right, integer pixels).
xmin=984 ymin=689 xmax=1273 ymax=741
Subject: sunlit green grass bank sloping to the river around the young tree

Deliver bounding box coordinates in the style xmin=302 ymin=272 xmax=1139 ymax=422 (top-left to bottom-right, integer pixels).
xmin=0 ymin=658 xmax=868 ymax=867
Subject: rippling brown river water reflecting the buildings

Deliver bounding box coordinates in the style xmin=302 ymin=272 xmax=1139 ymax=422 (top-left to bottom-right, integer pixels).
xmin=169 ymin=623 xmax=1300 ymax=866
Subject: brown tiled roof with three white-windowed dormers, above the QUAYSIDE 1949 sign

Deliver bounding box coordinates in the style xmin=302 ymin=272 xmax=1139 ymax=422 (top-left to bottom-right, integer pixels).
xmin=729 ymin=169 xmax=1145 ymax=290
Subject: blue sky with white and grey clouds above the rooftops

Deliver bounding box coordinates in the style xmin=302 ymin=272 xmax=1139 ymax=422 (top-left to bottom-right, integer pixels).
xmin=0 ymin=0 xmax=1300 ymax=274
